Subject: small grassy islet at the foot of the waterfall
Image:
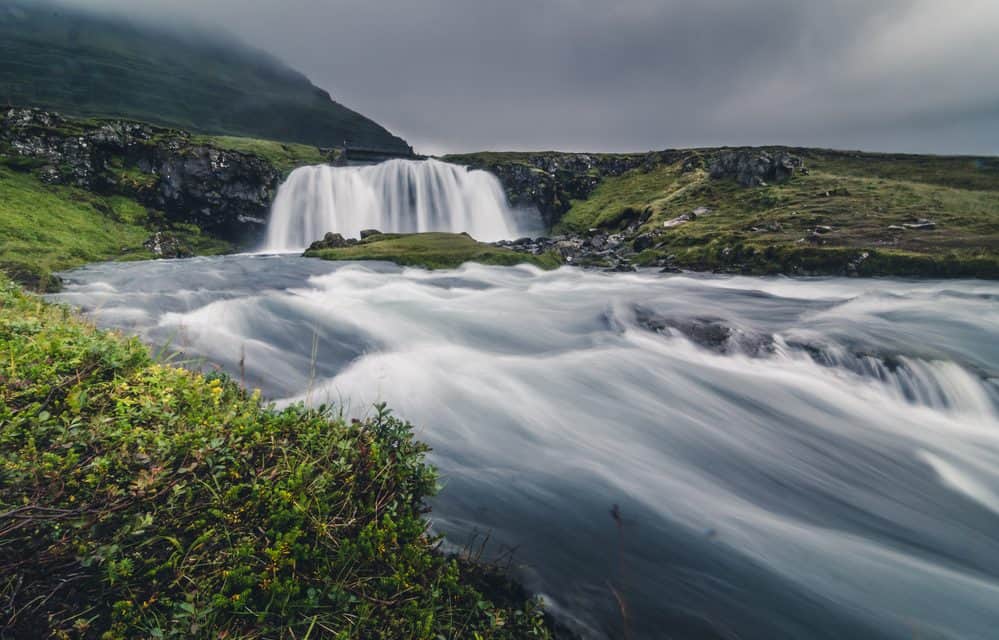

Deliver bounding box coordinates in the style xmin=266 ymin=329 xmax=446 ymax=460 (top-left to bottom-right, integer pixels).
xmin=305 ymin=233 xmax=561 ymax=269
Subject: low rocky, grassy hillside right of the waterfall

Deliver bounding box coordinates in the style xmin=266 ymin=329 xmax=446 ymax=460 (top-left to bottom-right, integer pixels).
xmin=446 ymin=147 xmax=999 ymax=278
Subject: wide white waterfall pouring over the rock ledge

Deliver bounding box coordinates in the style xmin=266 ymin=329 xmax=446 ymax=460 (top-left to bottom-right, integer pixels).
xmin=263 ymin=160 xmax=541 ymax=252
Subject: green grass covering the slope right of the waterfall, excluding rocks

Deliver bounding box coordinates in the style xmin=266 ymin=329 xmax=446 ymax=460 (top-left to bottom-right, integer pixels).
xmin=557 ymin=150 xmax=999 ymax=278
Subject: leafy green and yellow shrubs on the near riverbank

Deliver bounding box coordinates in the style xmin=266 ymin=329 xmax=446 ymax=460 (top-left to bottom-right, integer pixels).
xmin=0 ymin=280 xmax=549 ymax=639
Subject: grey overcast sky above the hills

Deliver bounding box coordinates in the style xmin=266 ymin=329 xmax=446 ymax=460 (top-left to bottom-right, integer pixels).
xmin=60 ymin=0 xmax=999 ymax=154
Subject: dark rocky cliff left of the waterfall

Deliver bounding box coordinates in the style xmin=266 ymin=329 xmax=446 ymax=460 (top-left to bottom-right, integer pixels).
xmin=0 ymin=109 xmax=282 ymax=242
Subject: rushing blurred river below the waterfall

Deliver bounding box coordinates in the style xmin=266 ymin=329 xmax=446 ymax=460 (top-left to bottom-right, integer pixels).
xmin=50 ymin=256 xmax=999 ymax=640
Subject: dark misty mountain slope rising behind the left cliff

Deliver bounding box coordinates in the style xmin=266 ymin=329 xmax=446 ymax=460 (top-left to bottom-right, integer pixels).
xmin=0 ymin=0 xmax=410 ymax=153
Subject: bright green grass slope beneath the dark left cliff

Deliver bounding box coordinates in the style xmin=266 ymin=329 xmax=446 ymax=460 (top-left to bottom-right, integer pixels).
xmin=0 ymin=164 xmax=232 ymax=290
